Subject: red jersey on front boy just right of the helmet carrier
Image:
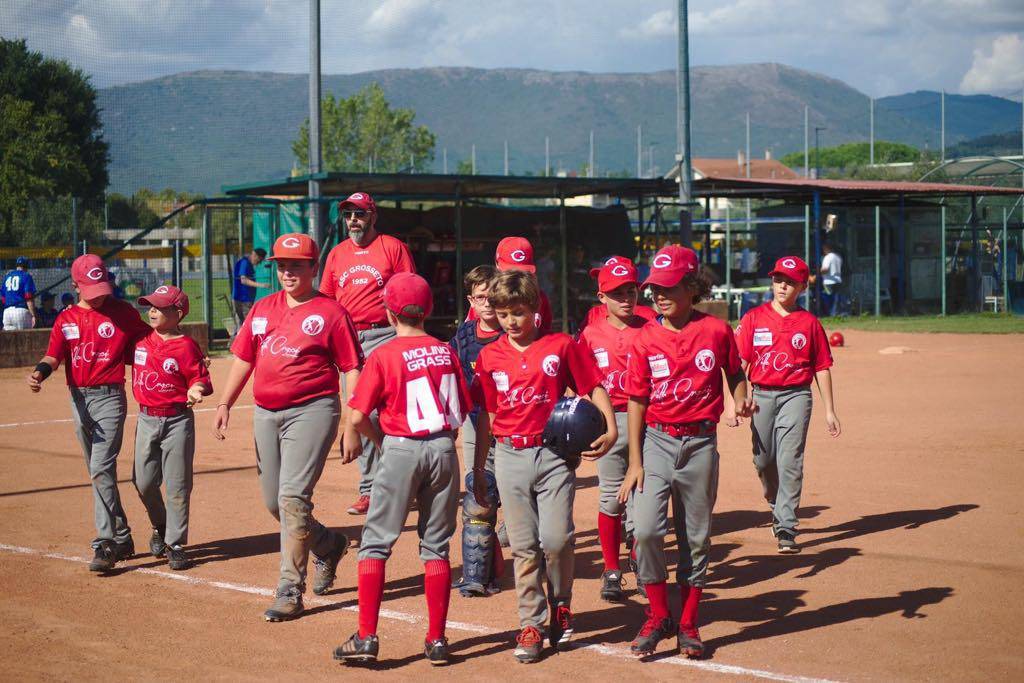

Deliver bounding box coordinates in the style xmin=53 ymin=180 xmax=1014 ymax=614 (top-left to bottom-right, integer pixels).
xmin=626 ymin=310 xmax=740 ymax=425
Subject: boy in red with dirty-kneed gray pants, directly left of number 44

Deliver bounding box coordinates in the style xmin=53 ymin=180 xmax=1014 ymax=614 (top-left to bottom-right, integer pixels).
xmin=214 ymin=233 xmax=362 ymax=622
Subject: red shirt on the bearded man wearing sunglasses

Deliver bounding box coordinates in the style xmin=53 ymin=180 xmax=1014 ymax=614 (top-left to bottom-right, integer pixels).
xmin=321 ymin=233 xmax=416 ymax=325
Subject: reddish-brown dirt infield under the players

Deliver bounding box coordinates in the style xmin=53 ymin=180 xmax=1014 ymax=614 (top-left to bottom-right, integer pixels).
xmin=0 ymin=332 xmax=1024 ymax=681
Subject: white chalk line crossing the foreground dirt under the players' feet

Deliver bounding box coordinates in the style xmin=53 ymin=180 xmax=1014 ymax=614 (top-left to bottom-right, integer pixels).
xmin=0 ymin=543 xmax=836 ymax=683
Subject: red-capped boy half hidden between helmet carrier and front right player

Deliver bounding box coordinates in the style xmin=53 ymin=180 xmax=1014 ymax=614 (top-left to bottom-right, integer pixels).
xmin=580 ymin=256 xmax=649 ymax=602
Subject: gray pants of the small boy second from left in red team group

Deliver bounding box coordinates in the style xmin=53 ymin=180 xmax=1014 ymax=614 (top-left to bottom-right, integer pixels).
xmin=132 ymin=409 xmax=196 ymax=548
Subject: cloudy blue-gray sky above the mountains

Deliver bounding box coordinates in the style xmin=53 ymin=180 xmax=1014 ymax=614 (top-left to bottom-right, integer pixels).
xmin=0 ymin=0 xmax=1024 ymax=99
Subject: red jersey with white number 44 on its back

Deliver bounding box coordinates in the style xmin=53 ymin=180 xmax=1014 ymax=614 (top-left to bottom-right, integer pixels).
xmin=348 ymin=335 xmax=473 ymax=436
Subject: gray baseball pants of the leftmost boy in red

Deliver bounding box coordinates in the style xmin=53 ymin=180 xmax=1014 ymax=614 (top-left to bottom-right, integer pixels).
xmin=69 ymin=384 xmax=131 ymax=548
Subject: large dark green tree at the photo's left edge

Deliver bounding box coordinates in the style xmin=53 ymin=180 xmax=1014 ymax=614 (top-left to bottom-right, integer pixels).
xmin=0 ymin=39 xmax=109 ymax=241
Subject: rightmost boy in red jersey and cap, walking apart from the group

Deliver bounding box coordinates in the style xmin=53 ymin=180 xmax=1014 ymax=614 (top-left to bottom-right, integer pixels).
xmin=736 ymin=256 xmax=841 ymax=553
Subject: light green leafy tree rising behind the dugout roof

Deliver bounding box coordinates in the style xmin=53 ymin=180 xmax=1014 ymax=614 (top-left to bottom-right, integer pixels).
xmin=292 ymin=83 xmax=436 ymax=173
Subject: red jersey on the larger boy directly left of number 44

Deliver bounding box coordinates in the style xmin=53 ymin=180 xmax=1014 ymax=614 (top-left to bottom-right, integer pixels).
xmin=231 ymin=292 xmax=362 ymax=411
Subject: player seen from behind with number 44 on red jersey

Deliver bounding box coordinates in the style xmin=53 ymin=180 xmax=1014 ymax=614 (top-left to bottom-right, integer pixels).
xmin=334 ymin=272 xmax=471 ymax=665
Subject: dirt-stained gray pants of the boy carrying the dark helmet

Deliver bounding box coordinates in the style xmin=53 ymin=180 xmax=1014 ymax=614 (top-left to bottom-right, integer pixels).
xmin=495 ymin=442 xmax=575 ymax=629
